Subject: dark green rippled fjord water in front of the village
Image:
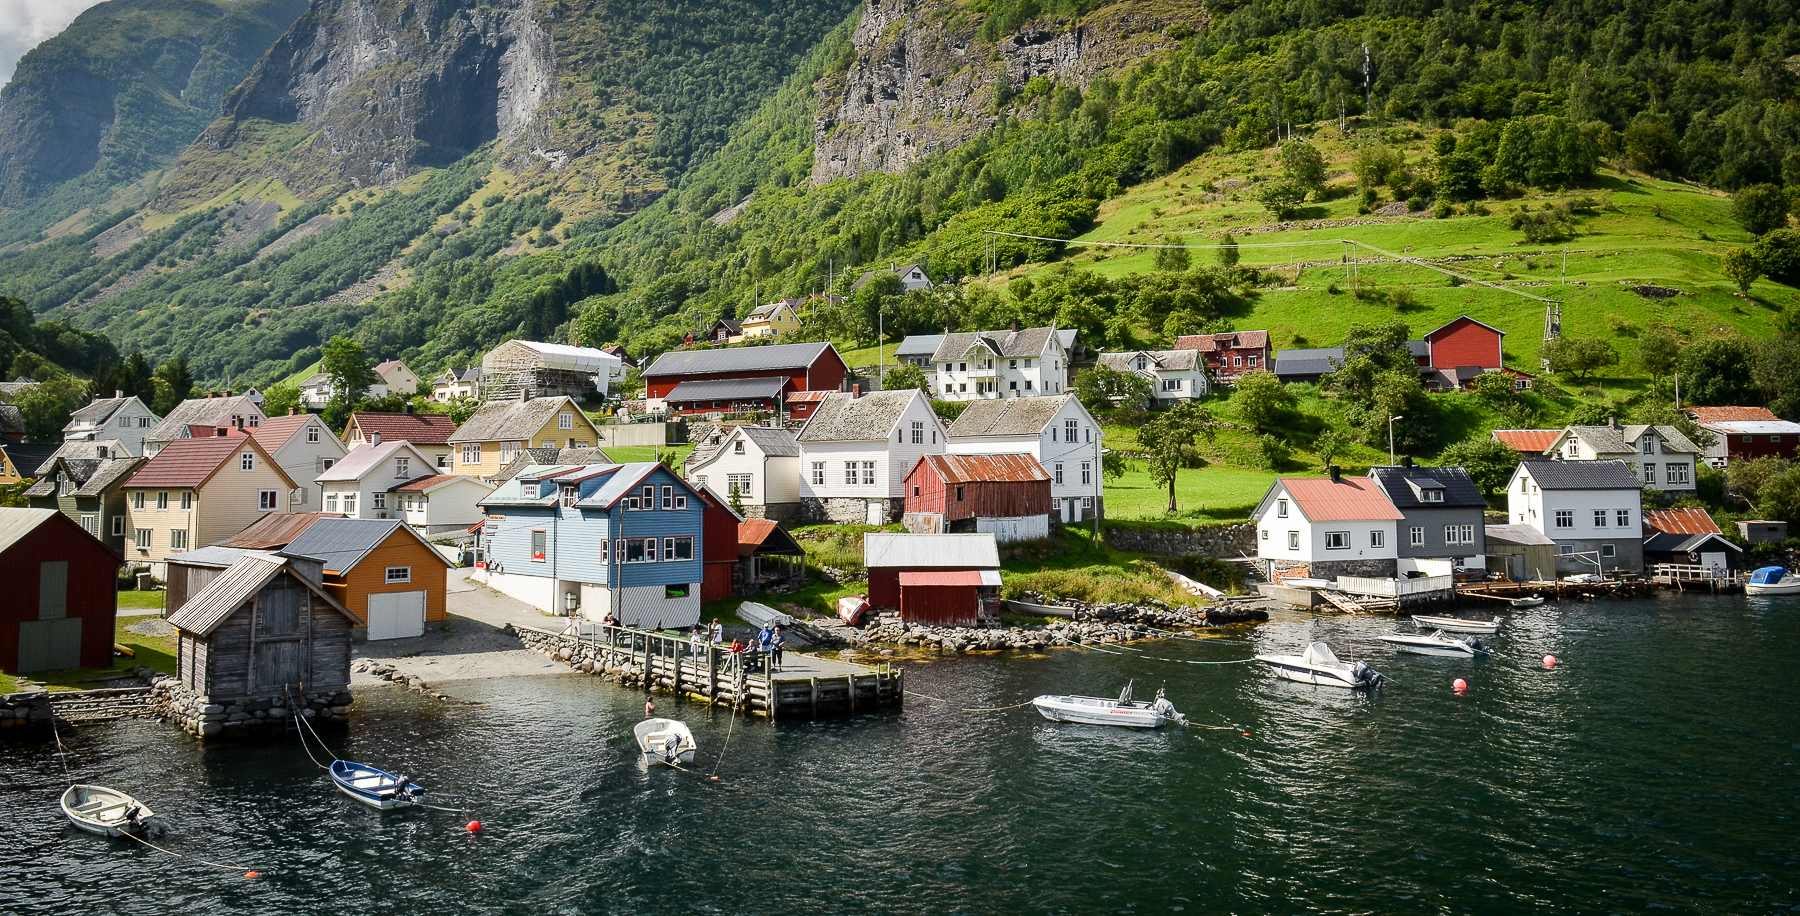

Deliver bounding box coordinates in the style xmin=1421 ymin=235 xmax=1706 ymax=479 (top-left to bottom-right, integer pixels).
xmin=0 ymin=596 xmax=1800 ymax=914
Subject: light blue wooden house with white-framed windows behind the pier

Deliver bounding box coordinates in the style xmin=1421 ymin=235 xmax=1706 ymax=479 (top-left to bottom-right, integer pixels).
xmin=477 ymin=462 xmax=706 ymax=626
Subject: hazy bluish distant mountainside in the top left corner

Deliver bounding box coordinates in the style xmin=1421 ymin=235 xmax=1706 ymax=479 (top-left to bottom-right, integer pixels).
xmin=0 ymin=0 xmax=306 ymax=245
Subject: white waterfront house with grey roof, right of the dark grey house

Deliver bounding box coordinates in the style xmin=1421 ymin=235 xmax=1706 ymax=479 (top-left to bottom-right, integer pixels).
xmin=1507 ymin=459 xmax=1643 ymax=576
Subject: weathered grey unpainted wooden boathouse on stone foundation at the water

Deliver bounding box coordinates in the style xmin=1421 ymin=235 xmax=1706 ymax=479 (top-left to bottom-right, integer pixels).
xmin=169 ymin=554 xmax=358 ymax=700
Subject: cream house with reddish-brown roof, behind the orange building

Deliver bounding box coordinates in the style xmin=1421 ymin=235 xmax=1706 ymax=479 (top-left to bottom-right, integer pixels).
xmin=124 ymin=427 xmax=299 ymax=578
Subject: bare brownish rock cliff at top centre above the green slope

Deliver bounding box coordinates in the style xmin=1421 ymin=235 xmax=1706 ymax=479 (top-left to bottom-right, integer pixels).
xmin=812 ymin=0 xmax=1206 ymax=184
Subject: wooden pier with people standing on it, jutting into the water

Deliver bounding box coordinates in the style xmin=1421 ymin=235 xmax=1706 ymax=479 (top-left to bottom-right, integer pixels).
xmin=513 ymin=624 xmax=905 ymax=720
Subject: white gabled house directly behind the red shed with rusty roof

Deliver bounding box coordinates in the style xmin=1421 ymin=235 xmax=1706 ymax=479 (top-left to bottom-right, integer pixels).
xmin=945 ymin=394 xmax=1105 ymax=524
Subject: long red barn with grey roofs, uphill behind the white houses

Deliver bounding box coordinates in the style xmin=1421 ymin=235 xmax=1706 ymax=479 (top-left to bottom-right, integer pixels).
xmin=643 ymin=342 xmax=848 ymax=412
